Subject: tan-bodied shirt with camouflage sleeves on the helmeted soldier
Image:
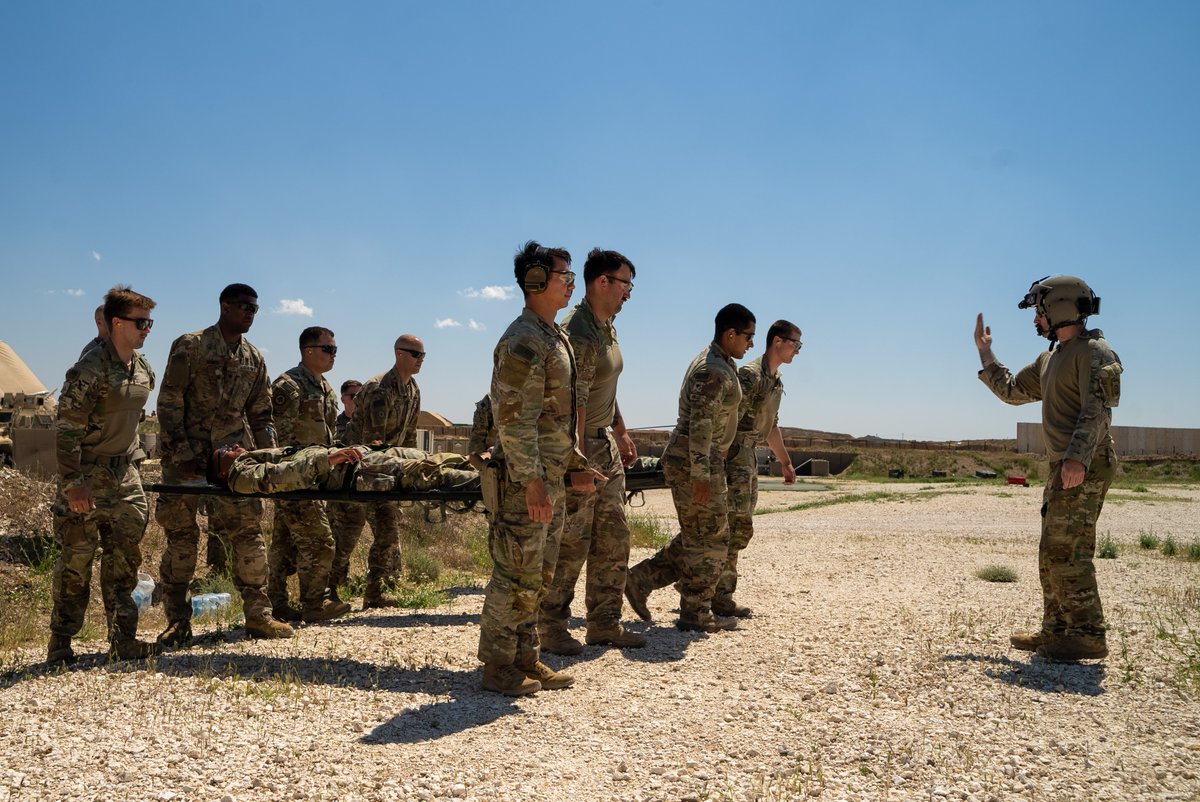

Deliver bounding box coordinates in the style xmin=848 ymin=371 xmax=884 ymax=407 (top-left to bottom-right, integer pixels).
xmin=979 ymin=329 xmax=1123 ymax=467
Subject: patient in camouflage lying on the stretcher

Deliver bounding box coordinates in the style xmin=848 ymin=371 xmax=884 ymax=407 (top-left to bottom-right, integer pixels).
xmin=209 ymin=445 xmax=479 ymax=493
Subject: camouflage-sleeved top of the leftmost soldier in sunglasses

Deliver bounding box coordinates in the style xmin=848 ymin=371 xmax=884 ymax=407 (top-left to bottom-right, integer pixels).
xmin=55 ymin=340 xmax=154 ymax=490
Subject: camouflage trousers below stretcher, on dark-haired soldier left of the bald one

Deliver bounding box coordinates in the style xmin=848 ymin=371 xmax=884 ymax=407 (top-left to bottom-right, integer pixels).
xmin=266 ymin=501 xmax=334 ymax=610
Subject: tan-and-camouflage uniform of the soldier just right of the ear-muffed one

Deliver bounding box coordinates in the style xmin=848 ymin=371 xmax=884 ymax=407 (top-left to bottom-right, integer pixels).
xmin=540 ymin=298 xmax=629 ymax=633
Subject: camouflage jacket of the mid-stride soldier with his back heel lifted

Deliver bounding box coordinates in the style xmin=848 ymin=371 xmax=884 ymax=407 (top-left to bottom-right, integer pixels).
xmin=664 ymin=342 xmax=742 ymax=481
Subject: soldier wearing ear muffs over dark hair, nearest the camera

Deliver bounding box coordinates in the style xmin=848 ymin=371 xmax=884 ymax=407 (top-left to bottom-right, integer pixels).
xmin=479 ymin=241 xmax=598 ymax=696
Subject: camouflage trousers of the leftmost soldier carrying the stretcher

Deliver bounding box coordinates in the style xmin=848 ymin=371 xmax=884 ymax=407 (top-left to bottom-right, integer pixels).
xmin=50 ymin=465 xmax=149 ymax=641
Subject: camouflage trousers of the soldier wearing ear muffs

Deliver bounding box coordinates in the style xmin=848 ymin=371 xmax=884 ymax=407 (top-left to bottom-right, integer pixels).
xmin=478 ymin=478 xmax=566 ymax=666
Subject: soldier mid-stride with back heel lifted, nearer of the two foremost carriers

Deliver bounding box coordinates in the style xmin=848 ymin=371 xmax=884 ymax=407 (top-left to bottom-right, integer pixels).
xmin=625 ymin=304 xmax=755 ymax=633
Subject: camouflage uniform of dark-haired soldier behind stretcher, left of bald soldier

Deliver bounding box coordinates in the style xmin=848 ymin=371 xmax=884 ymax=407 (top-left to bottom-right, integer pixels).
xmin=266 ymin=365 xmax=337 ymax=610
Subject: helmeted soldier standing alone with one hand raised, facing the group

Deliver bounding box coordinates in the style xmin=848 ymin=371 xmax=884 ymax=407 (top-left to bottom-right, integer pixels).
xmin=974 ymin=276 xmax=1122 ymax=662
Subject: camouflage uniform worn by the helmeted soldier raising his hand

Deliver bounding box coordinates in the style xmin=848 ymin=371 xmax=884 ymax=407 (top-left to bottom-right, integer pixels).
xmin=979 ymin=329 xmax=1122 ymax=641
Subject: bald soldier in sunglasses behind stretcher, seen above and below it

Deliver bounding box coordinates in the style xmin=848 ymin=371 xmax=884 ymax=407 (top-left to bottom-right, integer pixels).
xmin=329 ymin=334 xmax=425 ymax=610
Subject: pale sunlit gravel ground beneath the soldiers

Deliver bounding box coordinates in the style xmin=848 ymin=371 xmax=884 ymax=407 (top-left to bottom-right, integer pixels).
xmin=0 ymin=480 xmax=1200 ymax=802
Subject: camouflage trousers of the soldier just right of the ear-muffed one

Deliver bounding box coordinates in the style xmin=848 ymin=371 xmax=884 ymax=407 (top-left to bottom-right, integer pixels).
xmin=539 ymin=433 xmax=629 ymax=628
